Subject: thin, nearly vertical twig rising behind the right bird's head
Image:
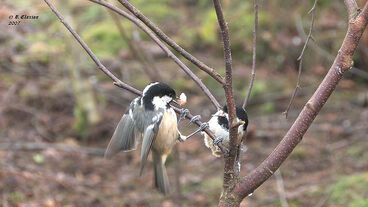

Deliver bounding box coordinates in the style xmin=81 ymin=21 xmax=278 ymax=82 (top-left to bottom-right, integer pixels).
xmin=243 ymin=0 xmax=258 ymax=109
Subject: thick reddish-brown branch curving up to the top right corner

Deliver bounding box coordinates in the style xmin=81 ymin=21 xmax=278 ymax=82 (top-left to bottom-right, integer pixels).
xmin=233 ymin=2 xmax=368 ymax=199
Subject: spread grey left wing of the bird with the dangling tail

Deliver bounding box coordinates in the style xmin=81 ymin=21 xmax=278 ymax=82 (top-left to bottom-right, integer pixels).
xmin=105 ymin=114 xmax=136 ymax=158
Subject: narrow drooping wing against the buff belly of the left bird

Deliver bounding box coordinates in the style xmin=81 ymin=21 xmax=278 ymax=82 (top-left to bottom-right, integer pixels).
xmin=140 ymin=112 xmax=163 ymax=175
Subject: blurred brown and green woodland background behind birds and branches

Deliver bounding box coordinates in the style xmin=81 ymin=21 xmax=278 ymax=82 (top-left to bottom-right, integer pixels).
xmin=0 ymin=0 xmax=368 ymax=207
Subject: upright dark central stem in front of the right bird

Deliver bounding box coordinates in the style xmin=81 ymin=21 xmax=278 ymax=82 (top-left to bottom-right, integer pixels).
xmin=213 ymin=0 xmax=238 ymax=196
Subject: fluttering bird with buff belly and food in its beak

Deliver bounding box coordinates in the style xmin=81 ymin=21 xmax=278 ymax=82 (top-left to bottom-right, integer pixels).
xmin=105 ymin=82 xmax=187 ymax=195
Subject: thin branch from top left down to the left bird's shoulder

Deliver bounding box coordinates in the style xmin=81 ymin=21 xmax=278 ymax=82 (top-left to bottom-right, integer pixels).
xmin=44 ymin=0 xmax=141 ymax=95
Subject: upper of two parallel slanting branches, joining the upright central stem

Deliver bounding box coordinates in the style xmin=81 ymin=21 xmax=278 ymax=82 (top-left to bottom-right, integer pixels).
xmin=119 ymin=0 xmax=225 ymax=84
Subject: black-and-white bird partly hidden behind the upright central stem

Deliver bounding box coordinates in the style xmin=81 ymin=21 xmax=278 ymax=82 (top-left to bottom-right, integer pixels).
xmin=202 ymin=105 xmax=248 ymax=157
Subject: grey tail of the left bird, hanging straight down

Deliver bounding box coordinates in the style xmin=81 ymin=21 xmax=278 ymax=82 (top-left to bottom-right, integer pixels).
xmin=152 ymin=151 xmax=170 ymax=195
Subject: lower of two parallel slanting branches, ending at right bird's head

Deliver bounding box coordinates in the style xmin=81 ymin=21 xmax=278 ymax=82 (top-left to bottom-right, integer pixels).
xmin=89 ymin=0 xmax=221 ymax=109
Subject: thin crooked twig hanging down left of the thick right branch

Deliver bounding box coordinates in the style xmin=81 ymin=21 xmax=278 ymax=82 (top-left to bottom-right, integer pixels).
xmin=283 ymin=0 xmax=318 ymax=118
